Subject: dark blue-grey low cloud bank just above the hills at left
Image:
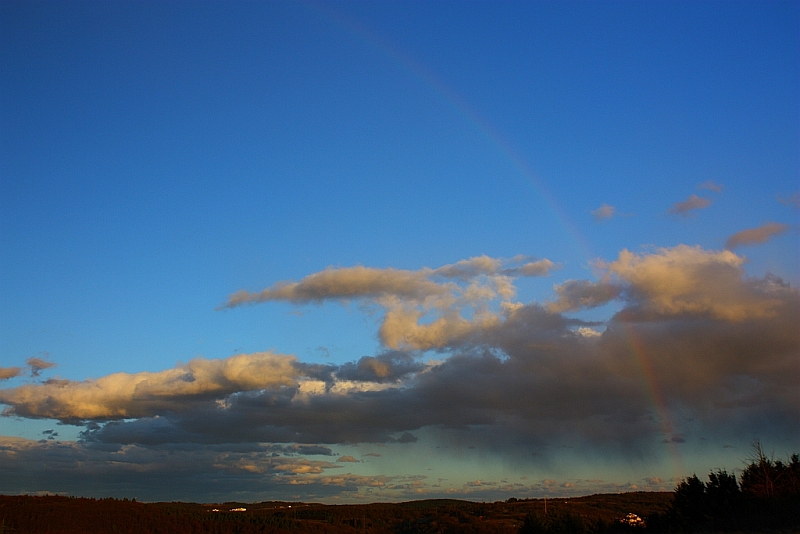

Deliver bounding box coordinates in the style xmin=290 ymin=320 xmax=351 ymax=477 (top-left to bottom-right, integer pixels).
xmin=0 ymin=436 xmax=390 ymax=502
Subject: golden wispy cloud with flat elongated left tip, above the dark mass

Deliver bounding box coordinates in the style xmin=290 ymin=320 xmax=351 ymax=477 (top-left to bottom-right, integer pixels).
xmin=219 ymin=256 xmax=557 ymax=354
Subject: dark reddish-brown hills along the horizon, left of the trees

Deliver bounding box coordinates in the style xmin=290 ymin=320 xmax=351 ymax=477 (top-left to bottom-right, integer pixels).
xmin=0 ymin=492 xmax=673 ymax=534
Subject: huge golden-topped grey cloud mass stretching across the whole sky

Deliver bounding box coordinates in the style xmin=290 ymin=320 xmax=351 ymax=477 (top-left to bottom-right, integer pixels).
xmin=0 ymin=246 xmax=800 ymax=465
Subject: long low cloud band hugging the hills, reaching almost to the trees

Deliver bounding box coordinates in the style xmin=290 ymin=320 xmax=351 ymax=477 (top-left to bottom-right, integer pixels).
xmin=0 ymin=437 xmax=669 ymax=503
